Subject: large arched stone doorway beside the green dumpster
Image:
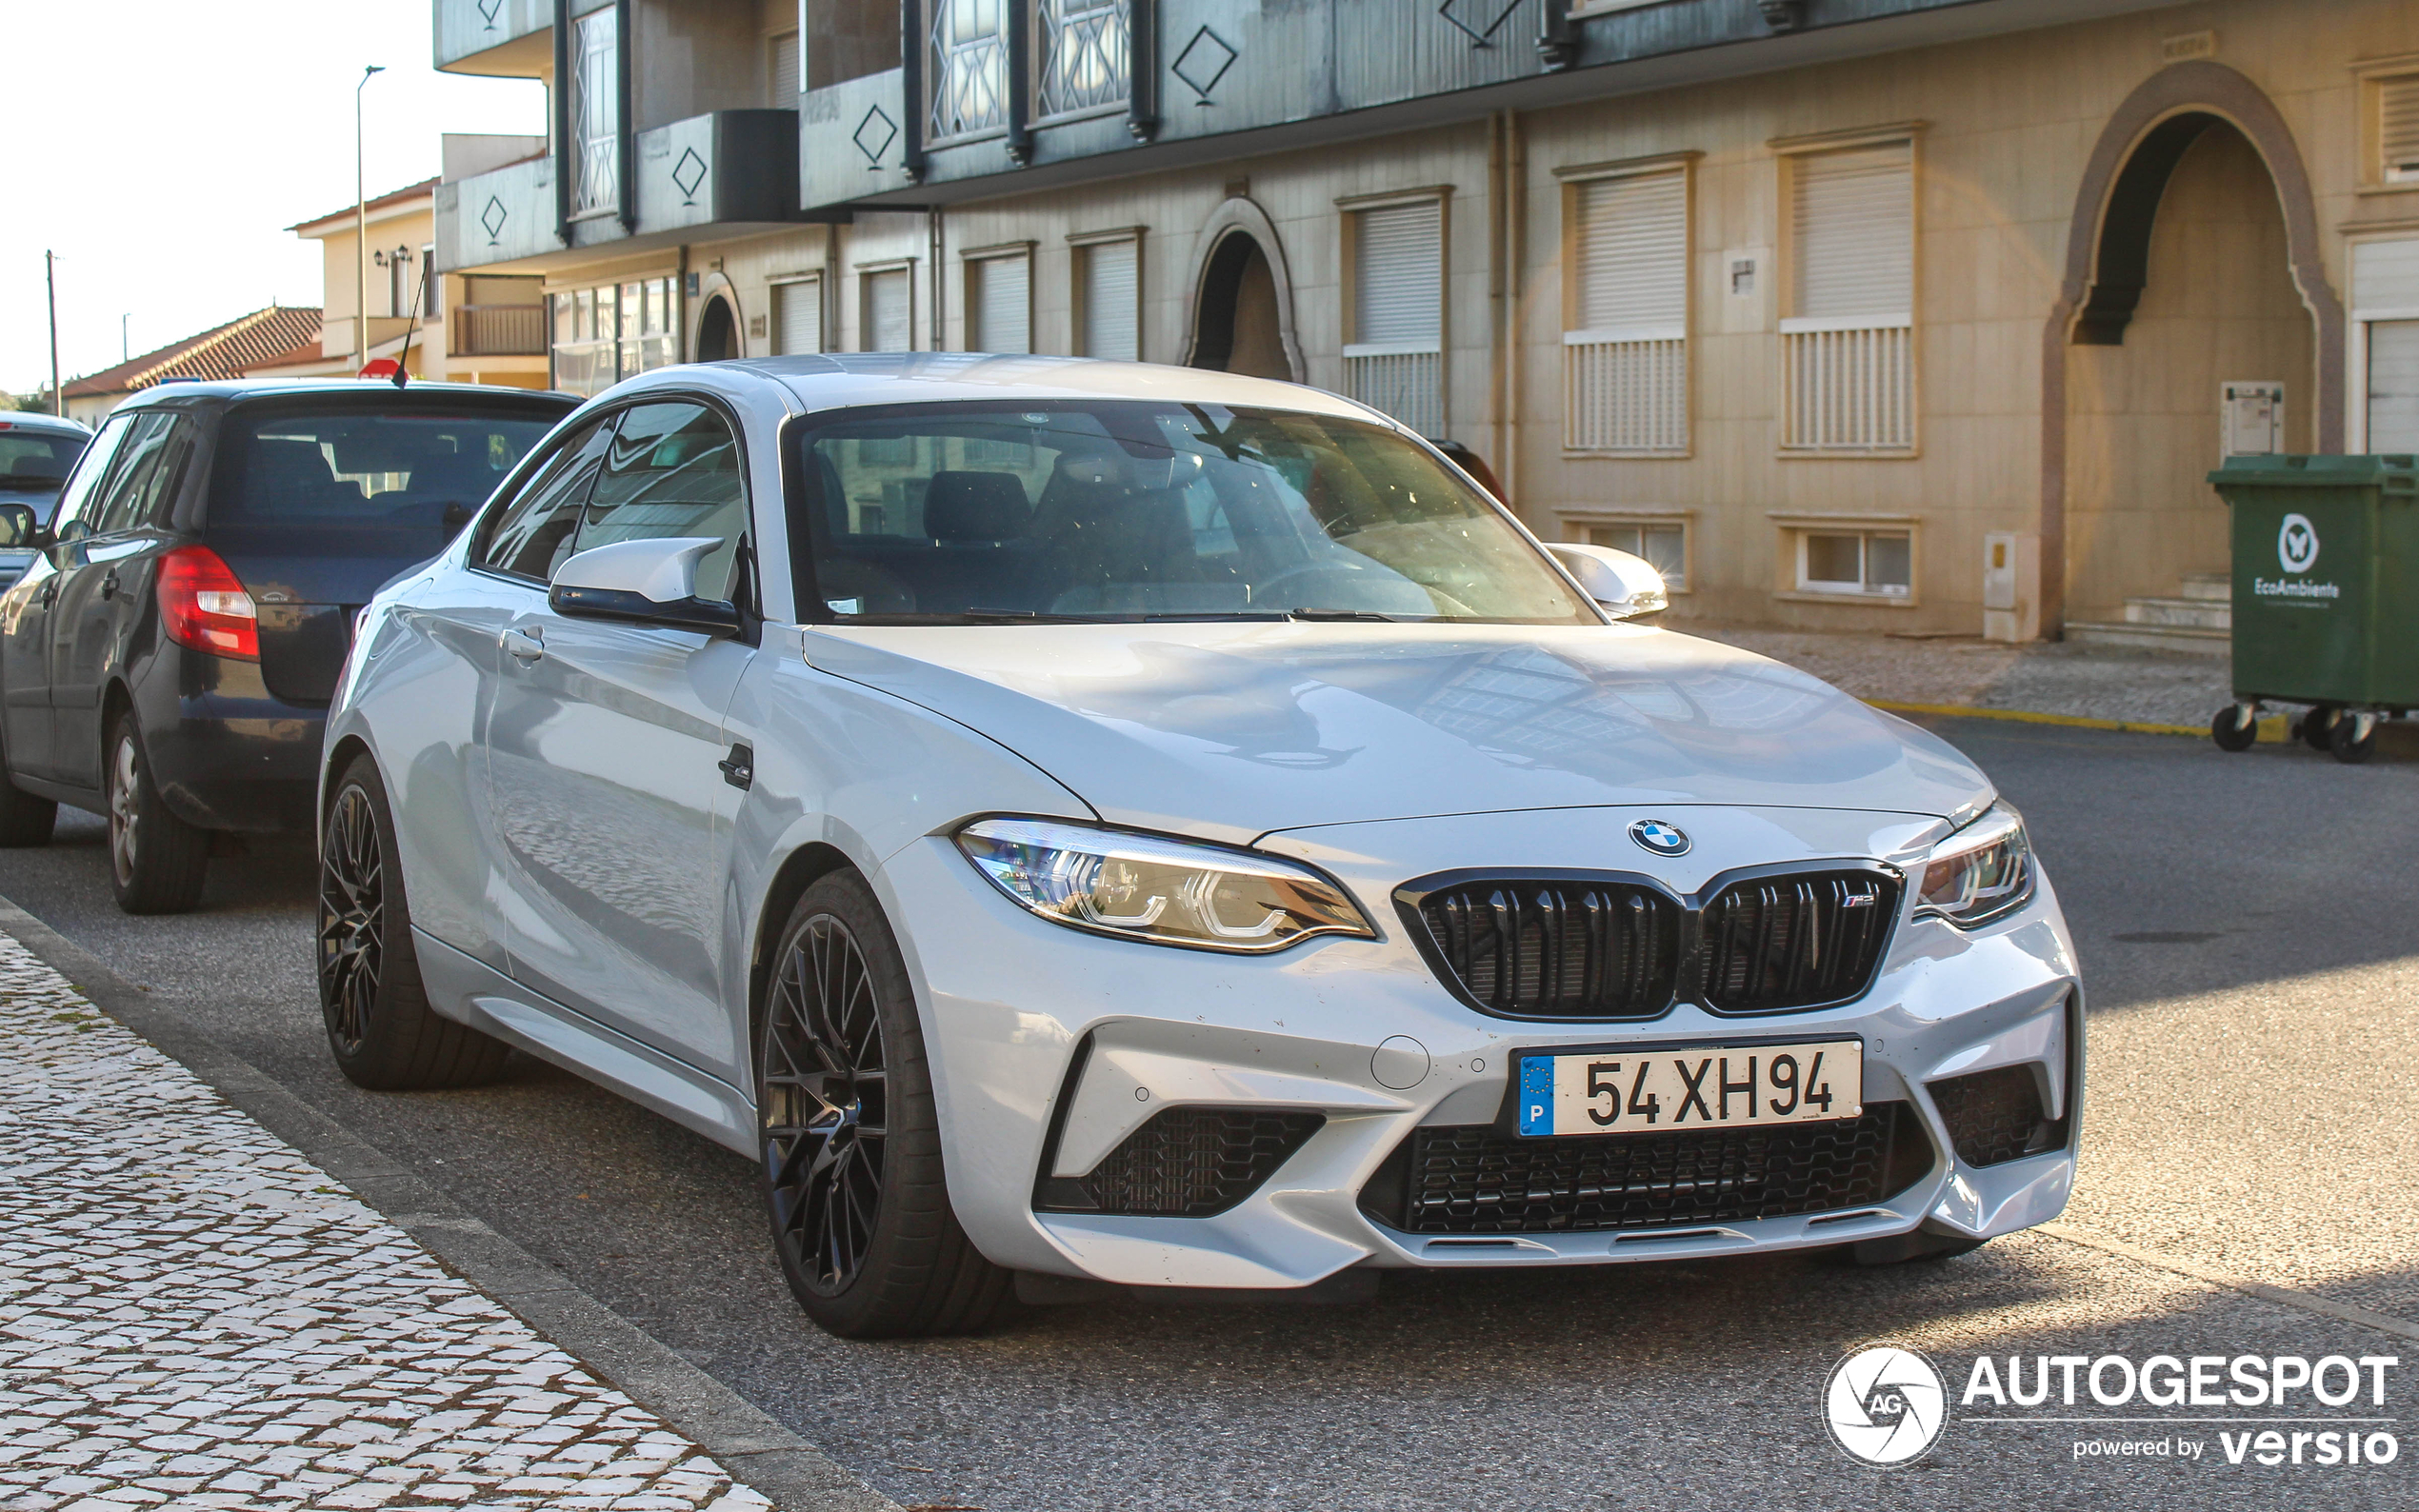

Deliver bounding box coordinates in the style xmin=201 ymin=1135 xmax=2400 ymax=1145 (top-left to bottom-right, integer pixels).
xmin=2042 ymin=63 xmax=2344 ymax=634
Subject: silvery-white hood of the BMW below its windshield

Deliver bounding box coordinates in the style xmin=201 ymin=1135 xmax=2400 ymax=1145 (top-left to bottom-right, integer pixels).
xmin=803 ymin=622 xmax=1993 ymax=842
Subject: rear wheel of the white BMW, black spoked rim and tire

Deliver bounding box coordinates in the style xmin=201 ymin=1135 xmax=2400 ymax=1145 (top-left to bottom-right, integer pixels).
xmin=319 ymin=757 xmax=510 ymax=1091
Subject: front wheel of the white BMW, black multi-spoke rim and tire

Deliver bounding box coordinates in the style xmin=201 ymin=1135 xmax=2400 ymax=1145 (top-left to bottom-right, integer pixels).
xmin=757 ymin=871 xmax=1011 ymax=1338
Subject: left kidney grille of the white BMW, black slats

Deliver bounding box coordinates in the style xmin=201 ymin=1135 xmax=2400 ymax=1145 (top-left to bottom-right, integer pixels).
xmin=1420 ymin=878 xmax=1681 ymax=1019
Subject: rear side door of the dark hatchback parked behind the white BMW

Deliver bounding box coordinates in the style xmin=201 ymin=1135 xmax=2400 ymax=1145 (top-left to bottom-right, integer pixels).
xmin=50 ymin=408 xmax=196 ymax=788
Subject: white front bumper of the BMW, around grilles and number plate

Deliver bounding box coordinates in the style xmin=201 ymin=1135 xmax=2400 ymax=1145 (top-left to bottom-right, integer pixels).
xmin=881 ymin=806 xmax=2080 ymax=1287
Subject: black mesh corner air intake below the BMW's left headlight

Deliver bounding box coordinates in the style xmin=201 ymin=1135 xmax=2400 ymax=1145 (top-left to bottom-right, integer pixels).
xmin=1033 ymin=1108 xmax=1326 ymax=1217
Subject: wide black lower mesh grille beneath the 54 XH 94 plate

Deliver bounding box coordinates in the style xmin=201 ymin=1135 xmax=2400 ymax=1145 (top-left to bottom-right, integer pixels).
xmin=1359 ymin=1104 xmax=1932 ymax=1234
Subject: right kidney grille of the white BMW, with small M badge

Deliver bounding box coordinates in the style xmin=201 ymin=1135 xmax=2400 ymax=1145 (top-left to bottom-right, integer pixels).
xmin=1698 ymin=871 xmax=1899 ymax=1014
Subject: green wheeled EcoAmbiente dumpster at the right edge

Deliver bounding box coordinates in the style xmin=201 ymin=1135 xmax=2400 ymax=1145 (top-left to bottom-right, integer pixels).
xmin=2209 ymin=455 xmax=2419 ymax=762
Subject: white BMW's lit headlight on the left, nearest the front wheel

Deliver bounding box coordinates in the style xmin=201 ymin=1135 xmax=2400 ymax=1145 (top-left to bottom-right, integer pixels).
xmin=958 ymin=818 xmax=1376 ymax=953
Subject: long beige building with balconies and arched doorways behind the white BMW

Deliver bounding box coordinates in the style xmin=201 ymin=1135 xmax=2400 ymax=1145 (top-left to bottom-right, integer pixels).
xmin=438 ymin=0 xmax=2419 ymax=641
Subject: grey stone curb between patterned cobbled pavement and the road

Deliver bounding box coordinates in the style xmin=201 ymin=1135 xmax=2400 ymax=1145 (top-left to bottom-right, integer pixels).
xmin=0 ymin=898 xmax=902 ymax=1512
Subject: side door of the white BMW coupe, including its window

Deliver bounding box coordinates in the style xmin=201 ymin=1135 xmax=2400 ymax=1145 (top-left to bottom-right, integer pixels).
xmin=487 ymin=402 xmax=752 ymax=1079
